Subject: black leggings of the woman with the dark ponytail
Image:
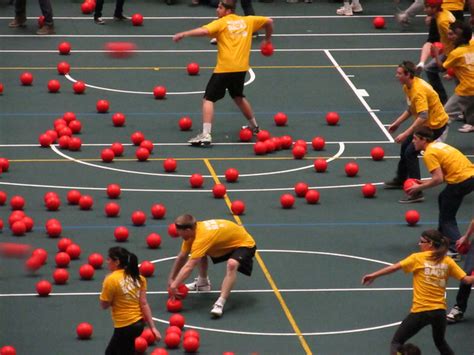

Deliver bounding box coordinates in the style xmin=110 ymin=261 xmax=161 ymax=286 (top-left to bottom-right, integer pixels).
xmin=105 ymin=319 xmax=145 ymax=355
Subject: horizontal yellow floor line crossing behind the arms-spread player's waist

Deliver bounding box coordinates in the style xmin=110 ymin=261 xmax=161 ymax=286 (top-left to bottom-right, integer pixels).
xmin=0 ymin=64 xmax=397 ymax=71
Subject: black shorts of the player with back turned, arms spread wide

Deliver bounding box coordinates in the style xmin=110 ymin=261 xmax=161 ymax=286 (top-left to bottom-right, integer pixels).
xmin=204 ymin=71 xmax=247 ymax=102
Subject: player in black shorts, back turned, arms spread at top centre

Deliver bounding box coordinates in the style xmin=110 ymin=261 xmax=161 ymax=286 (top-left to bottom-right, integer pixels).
xmin=173 ymin=0 xmax=273 ymax=146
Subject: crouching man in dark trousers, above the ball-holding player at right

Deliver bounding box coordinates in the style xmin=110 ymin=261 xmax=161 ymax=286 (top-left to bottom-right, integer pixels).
xmin=385 ymin=61 xmax=448 ymax=203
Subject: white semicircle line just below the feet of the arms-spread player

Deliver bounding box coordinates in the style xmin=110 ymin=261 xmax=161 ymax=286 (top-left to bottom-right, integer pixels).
xmin=50 ymin=143 xmax=345 ymax=178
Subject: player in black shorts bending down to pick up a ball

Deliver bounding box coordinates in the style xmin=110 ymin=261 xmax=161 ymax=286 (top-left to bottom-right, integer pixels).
xmin=168 ymin=214 xmax=257 ymax=317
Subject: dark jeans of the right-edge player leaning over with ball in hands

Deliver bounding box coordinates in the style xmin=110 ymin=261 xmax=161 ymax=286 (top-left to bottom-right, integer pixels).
xmin=438 ymin=176 xmax=474 ymax=249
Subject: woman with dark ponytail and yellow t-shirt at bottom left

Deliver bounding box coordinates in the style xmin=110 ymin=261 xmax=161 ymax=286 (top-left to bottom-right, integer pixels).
xmin=100 ymin=247 xmax=161 ymax=355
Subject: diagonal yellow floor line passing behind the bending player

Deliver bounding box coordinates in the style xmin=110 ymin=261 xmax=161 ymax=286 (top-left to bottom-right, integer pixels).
xmin=204 ymin=159 xmax=312 ymax=355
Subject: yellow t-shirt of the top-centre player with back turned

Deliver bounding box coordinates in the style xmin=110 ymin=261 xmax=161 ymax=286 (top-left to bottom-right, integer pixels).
xmin=203 ymin=14 xmax=268 ymax=73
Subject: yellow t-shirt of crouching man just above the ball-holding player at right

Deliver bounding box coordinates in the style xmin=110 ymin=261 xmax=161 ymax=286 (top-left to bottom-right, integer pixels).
xmin=403 ymin=77 xmax=448 ymax=129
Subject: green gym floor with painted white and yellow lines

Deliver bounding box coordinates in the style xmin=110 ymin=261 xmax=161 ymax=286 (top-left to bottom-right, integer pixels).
xmin=0 ymin=0 xmax=474 ymax=355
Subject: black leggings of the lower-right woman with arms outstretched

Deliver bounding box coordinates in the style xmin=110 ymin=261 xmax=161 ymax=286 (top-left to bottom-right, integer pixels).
xmin=390 ymin=309 xmax=454 ymax=355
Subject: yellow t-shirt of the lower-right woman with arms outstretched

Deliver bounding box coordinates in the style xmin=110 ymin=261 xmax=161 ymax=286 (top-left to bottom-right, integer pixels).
xmin=400 ymin=251 xmax=466 ymax=313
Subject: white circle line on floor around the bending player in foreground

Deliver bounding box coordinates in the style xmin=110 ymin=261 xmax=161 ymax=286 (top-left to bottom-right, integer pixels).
xmin=151 ymin=249 xmax=401 ymax=336
